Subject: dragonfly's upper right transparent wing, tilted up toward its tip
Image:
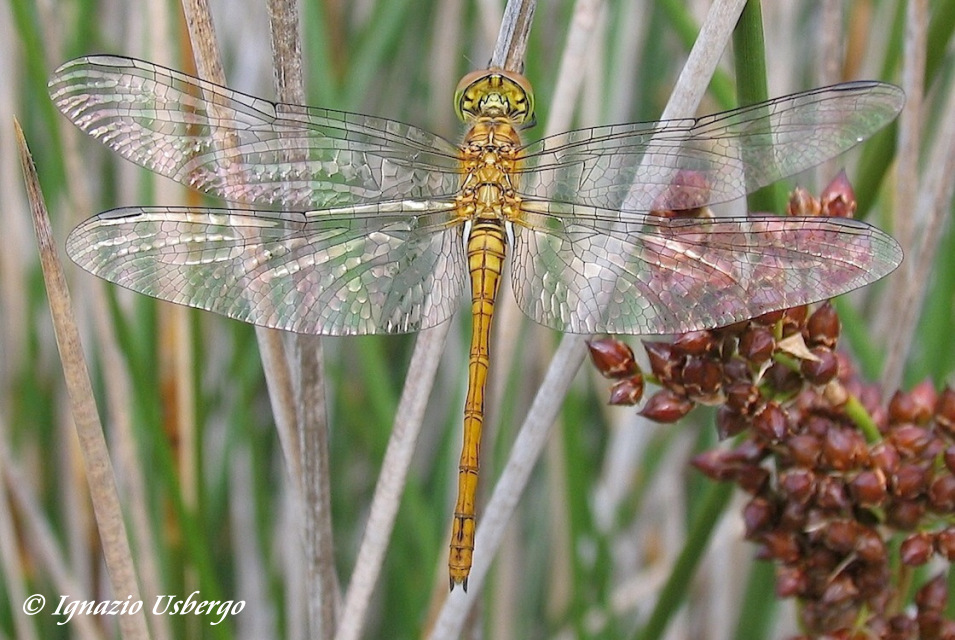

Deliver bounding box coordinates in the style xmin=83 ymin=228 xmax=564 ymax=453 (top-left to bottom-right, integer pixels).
xmin=518 ymin=82 xmax=905 ymax=212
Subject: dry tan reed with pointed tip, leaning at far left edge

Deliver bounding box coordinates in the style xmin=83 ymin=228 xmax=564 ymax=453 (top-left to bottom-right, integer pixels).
xmin=16 ymin=123 xmax=150 ymax=640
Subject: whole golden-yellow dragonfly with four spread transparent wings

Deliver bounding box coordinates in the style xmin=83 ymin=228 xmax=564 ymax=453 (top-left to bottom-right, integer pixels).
xmin=49 ymin=56 xmax=904 ymax=590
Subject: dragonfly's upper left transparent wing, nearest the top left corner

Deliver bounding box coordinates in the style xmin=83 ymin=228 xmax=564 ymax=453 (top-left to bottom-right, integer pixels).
xmin=50 ymin=56 xmax=460 ymax=210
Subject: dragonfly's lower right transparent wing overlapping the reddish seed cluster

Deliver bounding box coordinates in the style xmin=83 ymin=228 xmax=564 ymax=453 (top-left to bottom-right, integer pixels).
xmin=512 ymin=205 xmax=902 ymax=334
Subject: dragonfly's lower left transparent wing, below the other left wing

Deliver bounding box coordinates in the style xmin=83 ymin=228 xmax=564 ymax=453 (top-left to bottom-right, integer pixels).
xmin=66 ymin=202 xmax=467 ymax=335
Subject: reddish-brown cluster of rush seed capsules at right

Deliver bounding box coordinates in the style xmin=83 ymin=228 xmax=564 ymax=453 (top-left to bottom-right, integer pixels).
xmin=590 ymin=178 xmax=955 ymax=640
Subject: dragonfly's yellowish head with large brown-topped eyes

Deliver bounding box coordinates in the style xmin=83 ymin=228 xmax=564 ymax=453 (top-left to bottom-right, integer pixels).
xmin=454 ymin=69 xmax=534 ymax=126
